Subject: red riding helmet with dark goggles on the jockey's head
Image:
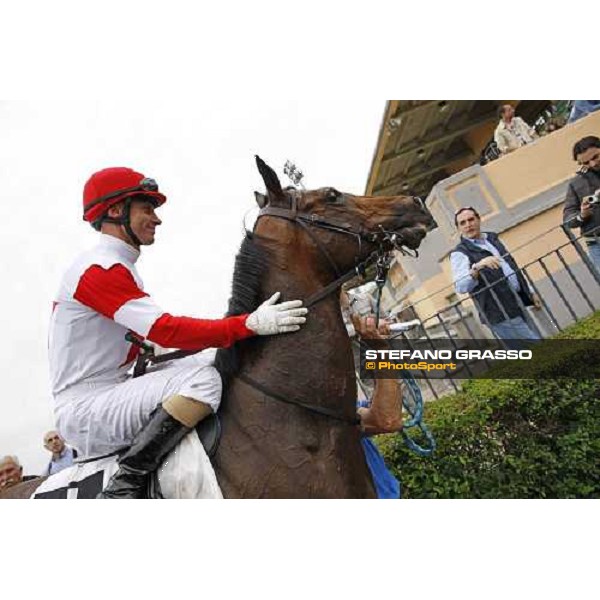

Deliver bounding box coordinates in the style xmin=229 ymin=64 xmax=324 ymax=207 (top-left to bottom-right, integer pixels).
xmin=83 ymin=167 xmax=167 ymax=229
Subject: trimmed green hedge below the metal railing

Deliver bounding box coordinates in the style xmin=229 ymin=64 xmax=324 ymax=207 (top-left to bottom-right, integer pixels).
xmin=377 ymin=313 xmax=600 ymax=498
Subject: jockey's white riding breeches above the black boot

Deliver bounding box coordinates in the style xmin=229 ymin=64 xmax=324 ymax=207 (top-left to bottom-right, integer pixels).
xmin=55 ymin=352 xmax=222 ymax=457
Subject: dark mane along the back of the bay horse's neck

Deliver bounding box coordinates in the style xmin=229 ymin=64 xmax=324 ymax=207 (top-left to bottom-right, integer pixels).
xmin=215 ymin=232 xmax=269 ymax=387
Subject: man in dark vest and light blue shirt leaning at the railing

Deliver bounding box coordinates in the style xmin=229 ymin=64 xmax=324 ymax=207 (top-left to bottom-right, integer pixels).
xmin=450 ymin=206 xmax=541 ymax=346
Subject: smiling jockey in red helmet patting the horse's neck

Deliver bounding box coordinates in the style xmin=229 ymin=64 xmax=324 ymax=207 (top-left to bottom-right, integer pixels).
xmin=49 ymin=167 xmax=307 ymax=498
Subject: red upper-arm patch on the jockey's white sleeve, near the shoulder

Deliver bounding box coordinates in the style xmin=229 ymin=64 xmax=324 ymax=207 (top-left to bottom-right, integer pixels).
xmin=73 ymin=264 xmax=148 ymax=319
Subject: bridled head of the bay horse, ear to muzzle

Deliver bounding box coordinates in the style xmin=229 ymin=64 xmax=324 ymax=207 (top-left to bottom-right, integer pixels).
xmin=256 ymin=156 xmax=436 ymax=268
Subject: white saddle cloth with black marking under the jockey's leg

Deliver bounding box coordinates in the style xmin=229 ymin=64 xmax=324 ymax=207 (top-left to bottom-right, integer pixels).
xmin=31 ymin=431 xmax=223 ymax=500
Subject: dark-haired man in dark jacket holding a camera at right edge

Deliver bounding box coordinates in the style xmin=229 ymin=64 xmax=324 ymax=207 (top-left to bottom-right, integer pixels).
xmin=563 ymin=135 xmax=600 ymax=271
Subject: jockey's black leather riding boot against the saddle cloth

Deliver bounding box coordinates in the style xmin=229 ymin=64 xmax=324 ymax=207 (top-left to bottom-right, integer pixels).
xmin=98 ymin=406 xmax=191 ymax=499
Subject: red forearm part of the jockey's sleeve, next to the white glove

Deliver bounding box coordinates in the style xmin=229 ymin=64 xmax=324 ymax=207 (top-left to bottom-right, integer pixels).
xmin=148 ymin=313 xmax=255 ymax=350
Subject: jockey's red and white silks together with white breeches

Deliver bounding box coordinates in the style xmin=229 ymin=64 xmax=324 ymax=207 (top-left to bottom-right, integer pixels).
xmin=49 ymin=234 xmax=254 ymax=456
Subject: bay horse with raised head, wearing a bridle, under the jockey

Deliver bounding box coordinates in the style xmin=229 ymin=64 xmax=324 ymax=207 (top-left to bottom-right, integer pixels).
xmin=2 ymin=156 xmax=435 ymax=498
